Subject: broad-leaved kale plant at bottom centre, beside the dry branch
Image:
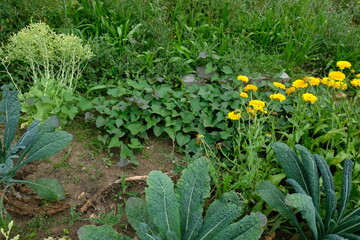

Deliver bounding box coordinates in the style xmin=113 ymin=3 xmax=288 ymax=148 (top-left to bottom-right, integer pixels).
xmin=125 ymin=159 xmax=266 ymax=239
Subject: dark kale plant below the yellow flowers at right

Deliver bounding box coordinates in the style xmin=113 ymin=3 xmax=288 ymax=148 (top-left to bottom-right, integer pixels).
xmin=256 ymin=142 xmax=360 ymax=240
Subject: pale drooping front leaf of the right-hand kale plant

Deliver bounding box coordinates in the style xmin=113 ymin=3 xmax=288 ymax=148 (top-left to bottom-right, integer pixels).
xmin=285 ymin=193 xmax=318 ymax=239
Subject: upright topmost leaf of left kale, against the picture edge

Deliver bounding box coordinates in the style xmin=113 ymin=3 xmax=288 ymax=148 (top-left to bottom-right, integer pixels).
xmin=0 ymin=85 xmax=21 ymax=149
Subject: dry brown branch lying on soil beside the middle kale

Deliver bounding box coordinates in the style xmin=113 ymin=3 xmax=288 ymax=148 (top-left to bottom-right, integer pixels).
xmin=80 ymin=171 xmax=173 ymax=213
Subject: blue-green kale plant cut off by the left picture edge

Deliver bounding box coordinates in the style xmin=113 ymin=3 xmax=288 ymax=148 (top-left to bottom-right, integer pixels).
xmin=0 ymin=85 xmax=72 ymax=223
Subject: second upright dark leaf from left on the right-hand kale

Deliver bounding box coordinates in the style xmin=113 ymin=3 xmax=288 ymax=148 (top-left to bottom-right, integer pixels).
xmin=295 ymin=144 xmax=320 ymax=212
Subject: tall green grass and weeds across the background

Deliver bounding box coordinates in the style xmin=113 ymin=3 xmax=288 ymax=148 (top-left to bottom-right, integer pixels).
xmin=0 ymin=0 xmax=360 ymax=88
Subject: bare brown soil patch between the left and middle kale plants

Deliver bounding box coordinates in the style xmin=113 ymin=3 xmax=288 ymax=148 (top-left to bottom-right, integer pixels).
xmin=6 ymin=126 xmax=181 ymax=240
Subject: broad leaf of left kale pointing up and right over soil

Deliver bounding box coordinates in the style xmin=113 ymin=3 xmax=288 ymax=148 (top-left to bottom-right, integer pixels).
xmin=25 ymin=131 xmax=72 ymax=163
